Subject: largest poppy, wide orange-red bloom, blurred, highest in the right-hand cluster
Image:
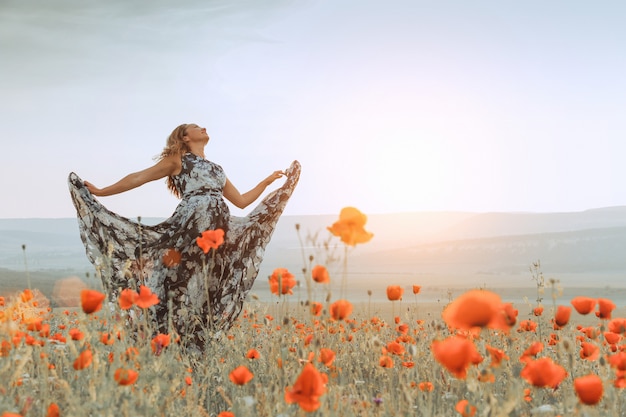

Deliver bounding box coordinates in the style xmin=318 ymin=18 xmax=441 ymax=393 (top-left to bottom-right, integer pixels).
xmin=441 ymin=290 xmax=510 ymax=330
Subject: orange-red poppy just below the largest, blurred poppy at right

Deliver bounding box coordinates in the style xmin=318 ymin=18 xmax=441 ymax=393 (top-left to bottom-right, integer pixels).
xmin=431 ymin=336 xmax=483 ymax=379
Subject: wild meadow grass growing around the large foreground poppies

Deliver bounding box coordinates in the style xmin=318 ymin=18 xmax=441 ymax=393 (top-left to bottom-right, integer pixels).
xmin=0 ymin=223 xmax=626 ymax=417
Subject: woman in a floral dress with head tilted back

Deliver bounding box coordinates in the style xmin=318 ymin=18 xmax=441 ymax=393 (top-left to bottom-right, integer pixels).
xmin=69 ymin=124 xmax=300 ymax=347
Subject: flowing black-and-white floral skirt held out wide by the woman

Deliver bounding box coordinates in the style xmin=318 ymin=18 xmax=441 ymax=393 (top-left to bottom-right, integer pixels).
xmin=68 ymin=161 xmax=300 ymax=345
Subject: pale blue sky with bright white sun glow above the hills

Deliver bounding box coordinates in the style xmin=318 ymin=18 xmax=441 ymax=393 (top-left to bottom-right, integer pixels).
xmin=0 ymin=0 xmax=626 ymax=218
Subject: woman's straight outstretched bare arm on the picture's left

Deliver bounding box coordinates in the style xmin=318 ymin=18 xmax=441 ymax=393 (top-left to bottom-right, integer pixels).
xmin=85 ymin=155 xmax=181 ymax=197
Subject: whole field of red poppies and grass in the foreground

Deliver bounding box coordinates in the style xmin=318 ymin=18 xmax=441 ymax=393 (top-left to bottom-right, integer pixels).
xmin=0 ymin=208 xmax=626 ymax=417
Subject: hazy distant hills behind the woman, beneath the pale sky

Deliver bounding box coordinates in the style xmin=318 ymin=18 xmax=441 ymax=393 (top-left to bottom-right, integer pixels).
xmin=0 ymin=207 xmax=626 ymax=300
